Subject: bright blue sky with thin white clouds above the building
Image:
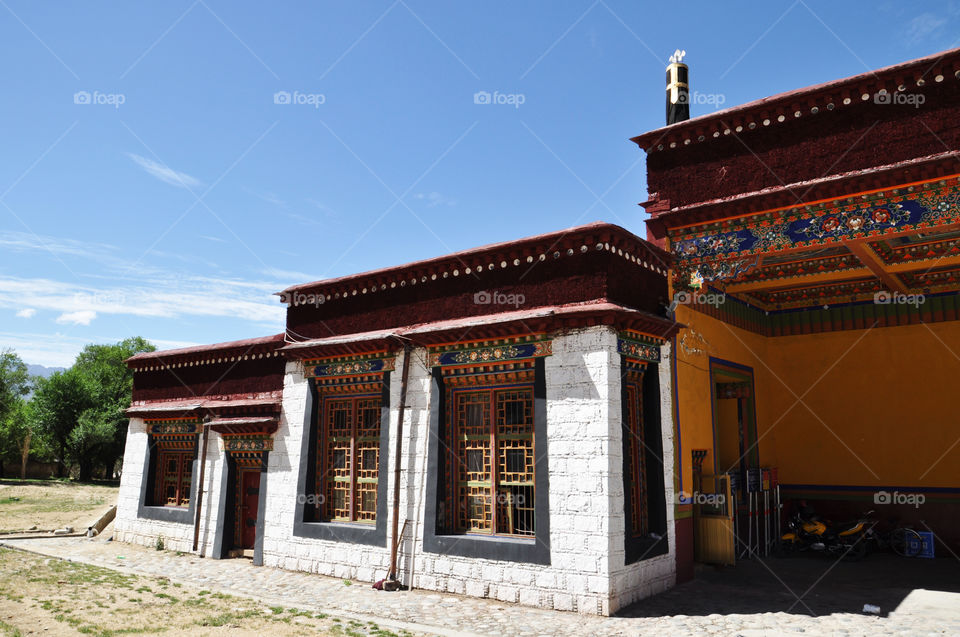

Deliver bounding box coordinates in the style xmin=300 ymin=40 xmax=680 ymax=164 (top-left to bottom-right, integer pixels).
xmin=0 ymin=0 xmax=960 ymax=365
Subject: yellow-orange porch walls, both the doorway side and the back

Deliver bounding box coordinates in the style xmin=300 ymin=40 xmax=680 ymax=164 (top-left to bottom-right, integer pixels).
xmin=676 ymin=306 xmax=960 ymax=491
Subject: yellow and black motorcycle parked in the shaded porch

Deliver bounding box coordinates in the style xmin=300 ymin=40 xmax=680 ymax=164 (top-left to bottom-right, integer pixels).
xmin=778 ymin=506 xmax=874 ymax=562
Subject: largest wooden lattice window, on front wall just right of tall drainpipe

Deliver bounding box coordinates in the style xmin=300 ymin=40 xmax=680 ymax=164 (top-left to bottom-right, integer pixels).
xmin=447 ymin=376 xmax=536 ymax=537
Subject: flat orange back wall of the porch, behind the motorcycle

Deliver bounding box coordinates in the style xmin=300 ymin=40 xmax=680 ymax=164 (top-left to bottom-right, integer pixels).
xmin=761 ymin=321 xmax=960 ymax=487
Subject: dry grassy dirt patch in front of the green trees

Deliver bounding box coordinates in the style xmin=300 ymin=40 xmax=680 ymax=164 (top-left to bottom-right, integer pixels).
xmin=0 ymin=479 xmax=117 ymax=534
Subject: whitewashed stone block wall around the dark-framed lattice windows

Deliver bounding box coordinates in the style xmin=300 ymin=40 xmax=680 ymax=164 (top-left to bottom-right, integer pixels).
xmin=117 ymin=326 xmax=674 ymax=614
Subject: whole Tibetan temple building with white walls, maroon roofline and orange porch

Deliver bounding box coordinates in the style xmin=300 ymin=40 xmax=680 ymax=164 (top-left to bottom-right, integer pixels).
xmin=116 ymin=44 xmax=960 ymax=614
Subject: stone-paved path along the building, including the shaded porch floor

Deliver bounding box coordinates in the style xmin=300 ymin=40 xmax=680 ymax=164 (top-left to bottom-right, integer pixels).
xmin=4 ymin=538 xmax=960 ymax=637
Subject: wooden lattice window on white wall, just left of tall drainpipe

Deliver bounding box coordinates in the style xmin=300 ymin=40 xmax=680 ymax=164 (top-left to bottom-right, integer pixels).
xmin=317 ymin=395 xmax=380 ymax=524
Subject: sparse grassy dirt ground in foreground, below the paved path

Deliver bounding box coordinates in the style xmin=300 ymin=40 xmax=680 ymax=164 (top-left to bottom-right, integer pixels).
xmin=0 ymin=549 xmax=410 ymax=637
